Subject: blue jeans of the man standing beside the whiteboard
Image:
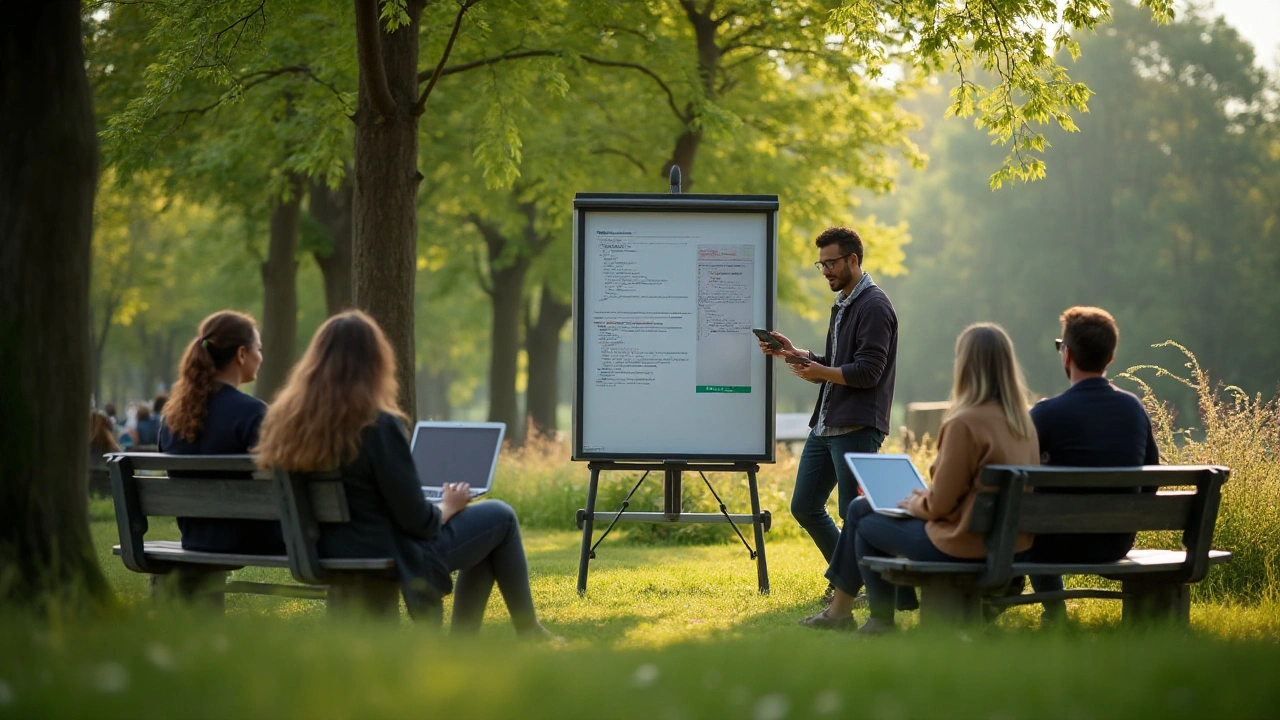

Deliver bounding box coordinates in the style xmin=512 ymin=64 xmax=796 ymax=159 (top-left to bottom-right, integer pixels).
xmin=791 ymin=428 xmax=884 ymax=562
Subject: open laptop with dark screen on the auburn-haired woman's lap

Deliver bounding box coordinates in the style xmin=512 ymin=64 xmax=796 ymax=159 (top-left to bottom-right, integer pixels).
xmin=408 ymin=420 xmax=507 ymax=502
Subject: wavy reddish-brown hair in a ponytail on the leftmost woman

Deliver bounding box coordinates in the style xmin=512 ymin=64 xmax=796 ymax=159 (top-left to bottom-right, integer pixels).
xmin=164 ymin=310 xmax=257 ymax=442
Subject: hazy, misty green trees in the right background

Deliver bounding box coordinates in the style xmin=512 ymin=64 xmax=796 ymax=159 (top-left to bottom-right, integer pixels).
xmin=869 ymin=4 xmax=1280 ymax=401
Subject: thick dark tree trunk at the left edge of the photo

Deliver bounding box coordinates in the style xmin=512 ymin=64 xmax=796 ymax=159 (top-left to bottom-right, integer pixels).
xmin=0 ymin=0 xmax=110 ymax=610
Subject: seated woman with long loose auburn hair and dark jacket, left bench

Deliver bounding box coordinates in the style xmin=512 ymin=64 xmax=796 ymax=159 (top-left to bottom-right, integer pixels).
xmin=257 ymin=311 xmax=553 ymax=638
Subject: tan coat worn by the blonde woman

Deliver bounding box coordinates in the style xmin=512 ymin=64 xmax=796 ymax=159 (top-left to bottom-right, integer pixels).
xmin=910 ymin=402 xmax=1039 ymax=560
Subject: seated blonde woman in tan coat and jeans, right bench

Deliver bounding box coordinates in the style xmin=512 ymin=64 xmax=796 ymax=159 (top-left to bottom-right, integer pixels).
xmin=801 ymin=323 xmax=1039 ymax=634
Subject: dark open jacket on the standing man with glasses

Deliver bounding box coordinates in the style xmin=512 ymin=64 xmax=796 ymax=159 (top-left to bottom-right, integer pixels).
xmin=809 ymin=286 xmax=897 ymax=434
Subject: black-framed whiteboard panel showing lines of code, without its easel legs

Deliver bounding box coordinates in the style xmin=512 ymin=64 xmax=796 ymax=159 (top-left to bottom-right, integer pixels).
xmin=573 ymin=193 xmax=777 ymax=462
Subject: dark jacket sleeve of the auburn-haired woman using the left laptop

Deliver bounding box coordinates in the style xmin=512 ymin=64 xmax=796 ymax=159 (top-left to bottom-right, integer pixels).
xmin=371 ymin=415 xmax=440 ymax=541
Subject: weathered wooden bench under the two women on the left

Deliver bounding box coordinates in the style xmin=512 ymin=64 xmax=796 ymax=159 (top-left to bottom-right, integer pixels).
xmin=108 ymin=452 xmax=409 ymax=618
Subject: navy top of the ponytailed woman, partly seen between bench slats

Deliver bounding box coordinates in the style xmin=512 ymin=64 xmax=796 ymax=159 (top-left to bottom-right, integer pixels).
xmin=159 ymin=384 xmax=284 ymax=555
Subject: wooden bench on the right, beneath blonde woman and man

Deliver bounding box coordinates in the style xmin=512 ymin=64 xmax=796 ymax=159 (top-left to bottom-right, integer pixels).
xmin=863 ymin=465 xmax=1231 ymax=624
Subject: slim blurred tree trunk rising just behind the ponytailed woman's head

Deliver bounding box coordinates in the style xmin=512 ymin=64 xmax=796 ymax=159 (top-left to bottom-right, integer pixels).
xmin=255 ymin=177 xmax=302 ymax=401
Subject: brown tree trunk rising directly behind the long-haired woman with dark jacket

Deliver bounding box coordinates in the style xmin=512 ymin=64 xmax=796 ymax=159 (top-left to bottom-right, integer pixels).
xmin=352 ymin=0 xmax=422 ymax=418
